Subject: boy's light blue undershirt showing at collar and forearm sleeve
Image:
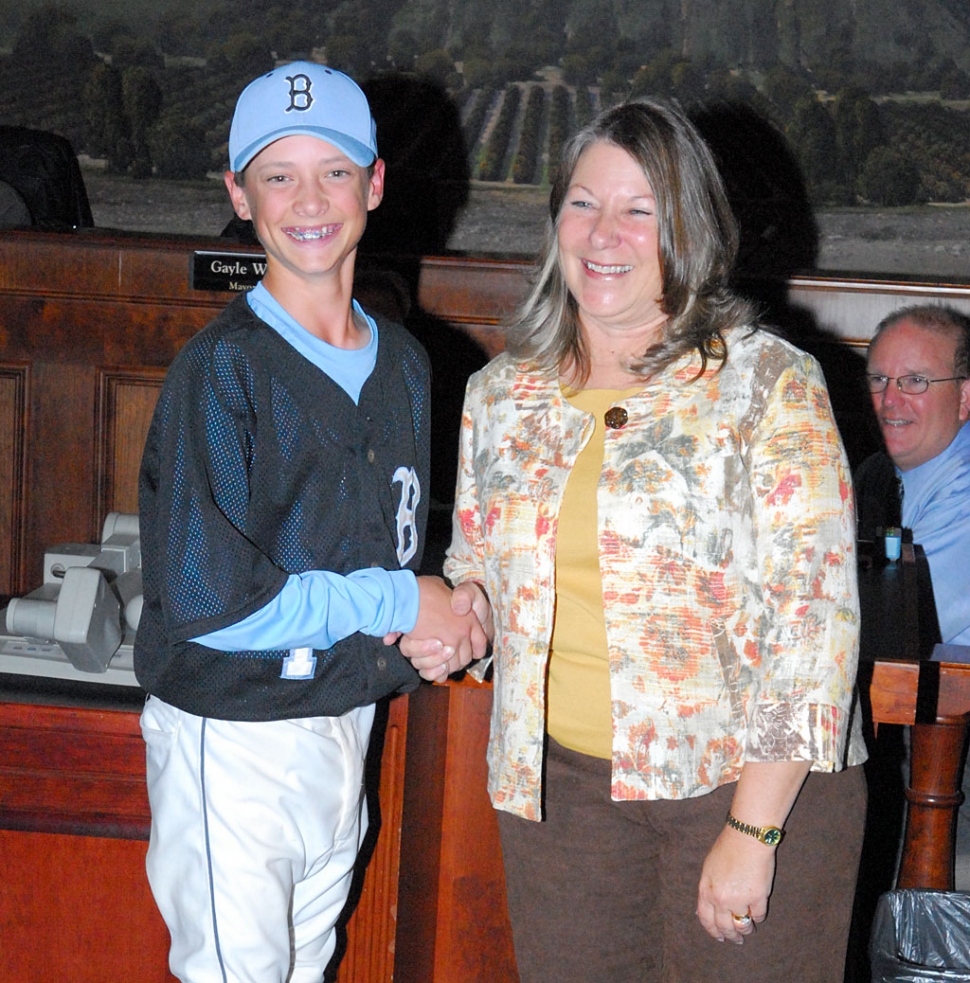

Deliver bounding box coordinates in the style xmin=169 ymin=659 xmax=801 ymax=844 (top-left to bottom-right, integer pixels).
xmin=193 ymin=283 xmax=418 ymax=652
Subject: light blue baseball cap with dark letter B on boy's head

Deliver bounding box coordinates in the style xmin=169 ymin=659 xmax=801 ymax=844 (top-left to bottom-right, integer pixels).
xmin=229 ymin=61 xmax=377 ymax=171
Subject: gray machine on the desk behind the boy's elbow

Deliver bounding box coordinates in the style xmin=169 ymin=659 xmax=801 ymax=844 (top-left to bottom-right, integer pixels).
xmin=0 ymin=512 xmax=142 ymax=686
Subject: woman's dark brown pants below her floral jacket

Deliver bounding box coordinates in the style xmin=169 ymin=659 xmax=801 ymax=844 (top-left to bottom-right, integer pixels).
xmin=498 ymin=740 xmax=866 ymax=983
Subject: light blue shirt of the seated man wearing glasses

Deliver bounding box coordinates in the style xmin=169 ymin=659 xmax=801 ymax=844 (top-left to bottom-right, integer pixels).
xmin=900 ymin=423 xmax=970 ymax=645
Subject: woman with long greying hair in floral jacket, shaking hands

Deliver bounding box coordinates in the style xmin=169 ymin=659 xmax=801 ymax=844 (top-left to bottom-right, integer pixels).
xmin=432 ymin=103 xmax=865 ymax=983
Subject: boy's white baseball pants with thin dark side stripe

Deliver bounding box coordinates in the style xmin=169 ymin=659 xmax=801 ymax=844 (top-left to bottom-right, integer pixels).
xmin=141 ymin=697 xmax=374 ymax=983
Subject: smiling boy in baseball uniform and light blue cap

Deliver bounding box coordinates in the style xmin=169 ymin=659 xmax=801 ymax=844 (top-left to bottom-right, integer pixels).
xmin=135 ymin=62 xmax=485 ymax=983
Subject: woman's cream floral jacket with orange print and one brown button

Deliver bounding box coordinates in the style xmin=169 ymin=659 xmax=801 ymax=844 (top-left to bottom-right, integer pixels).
xmin=445 ymin=329 xmax=865 ymax=819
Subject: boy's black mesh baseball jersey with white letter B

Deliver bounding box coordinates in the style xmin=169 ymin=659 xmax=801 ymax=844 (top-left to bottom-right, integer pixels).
xmin=135 ymin=295 xmax=430 ymax=720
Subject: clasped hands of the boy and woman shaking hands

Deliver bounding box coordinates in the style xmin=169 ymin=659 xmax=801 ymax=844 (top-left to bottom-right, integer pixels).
xmin=384 ymin=577 xmax=494 ymax=683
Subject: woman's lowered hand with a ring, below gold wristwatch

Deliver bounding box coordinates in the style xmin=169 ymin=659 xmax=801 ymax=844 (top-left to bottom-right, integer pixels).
xmin=697 ymin=826 xmax=775 ymax=944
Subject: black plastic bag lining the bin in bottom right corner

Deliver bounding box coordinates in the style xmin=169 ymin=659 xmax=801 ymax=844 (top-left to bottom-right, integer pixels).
xmin=869 ymin=890 xmax=970 ymax=983
